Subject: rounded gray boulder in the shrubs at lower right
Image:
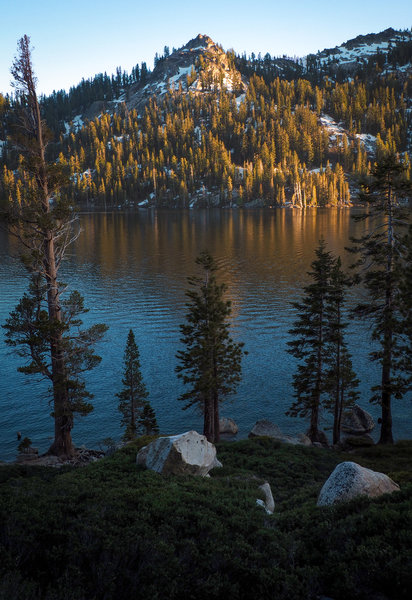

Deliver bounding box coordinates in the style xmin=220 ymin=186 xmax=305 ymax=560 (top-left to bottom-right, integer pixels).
xmin=318 ymin=462 xmax=400 ymax=506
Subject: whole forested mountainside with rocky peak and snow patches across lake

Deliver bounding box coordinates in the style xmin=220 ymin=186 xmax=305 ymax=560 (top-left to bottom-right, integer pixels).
xmin=0 ymin=29 xmax=412 ymax=207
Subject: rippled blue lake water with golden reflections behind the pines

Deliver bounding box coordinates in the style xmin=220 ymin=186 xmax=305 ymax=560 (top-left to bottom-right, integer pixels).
xmin=0 ymin=209 xmax=412 ymax=460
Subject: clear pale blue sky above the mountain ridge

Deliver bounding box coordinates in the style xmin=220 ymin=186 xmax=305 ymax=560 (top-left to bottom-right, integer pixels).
xmin=0 ymin=0 xmax=412 ymax=93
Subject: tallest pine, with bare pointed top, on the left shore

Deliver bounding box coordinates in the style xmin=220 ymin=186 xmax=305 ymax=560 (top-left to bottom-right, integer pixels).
xmin=2 ymin=35 xmax=107 ymax=457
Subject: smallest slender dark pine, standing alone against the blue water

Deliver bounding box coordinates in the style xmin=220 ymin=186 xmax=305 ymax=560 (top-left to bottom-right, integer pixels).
xmin=116 ymin=329 xmax=148 ymax=440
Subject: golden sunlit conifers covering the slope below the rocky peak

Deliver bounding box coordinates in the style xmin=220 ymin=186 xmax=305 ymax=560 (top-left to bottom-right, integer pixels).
xmin=2 ymin=47 xmax=411 ymax=207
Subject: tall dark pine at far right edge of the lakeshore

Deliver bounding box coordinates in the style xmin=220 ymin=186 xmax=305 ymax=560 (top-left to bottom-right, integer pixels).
xmin=350 ymin=154 xmax=410 ymax=444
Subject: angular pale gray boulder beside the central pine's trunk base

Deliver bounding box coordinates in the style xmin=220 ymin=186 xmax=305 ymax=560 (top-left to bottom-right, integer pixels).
xmin=136 ymin=431 xmax=222 ymax=477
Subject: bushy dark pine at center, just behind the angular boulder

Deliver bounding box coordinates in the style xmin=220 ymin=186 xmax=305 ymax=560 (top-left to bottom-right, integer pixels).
xmin=176 ymin=251 xmax=245 ymax=442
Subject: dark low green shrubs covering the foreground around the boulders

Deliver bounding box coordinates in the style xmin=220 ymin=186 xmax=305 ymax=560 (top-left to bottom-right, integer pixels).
xmin=0 ymin=438 xmax=412 ymax=600
